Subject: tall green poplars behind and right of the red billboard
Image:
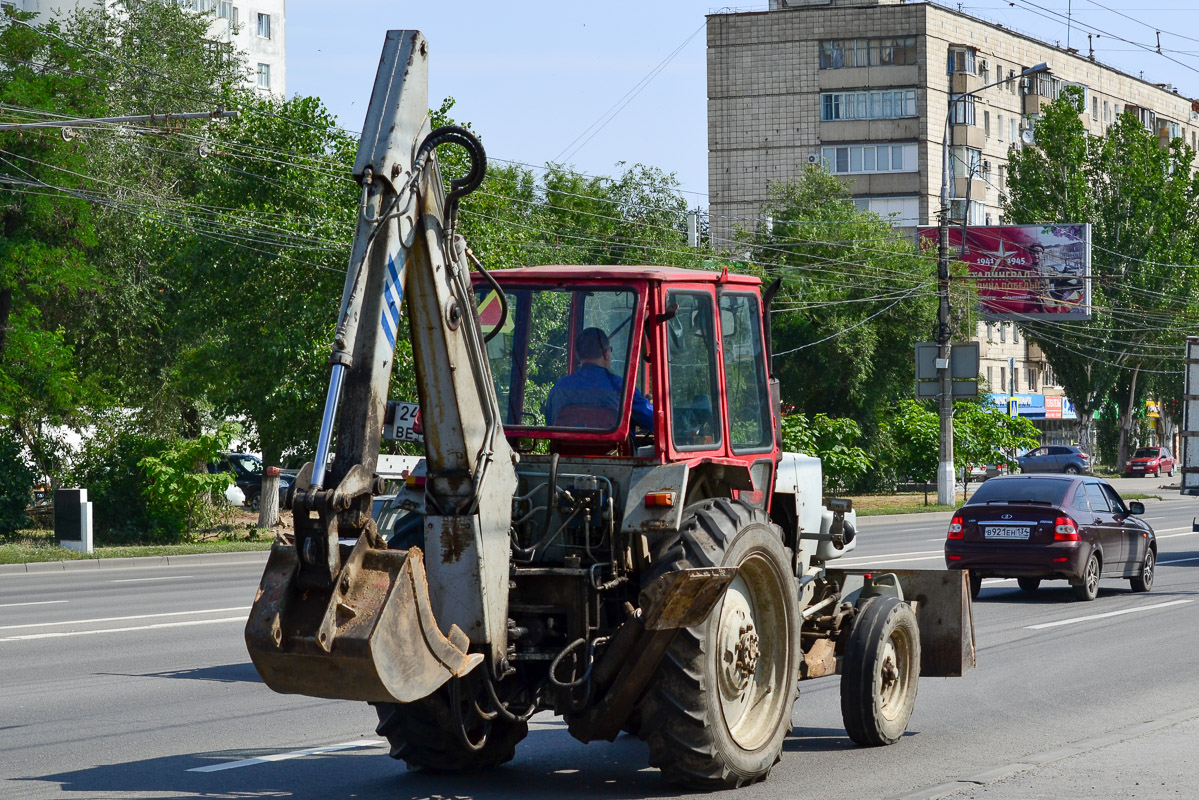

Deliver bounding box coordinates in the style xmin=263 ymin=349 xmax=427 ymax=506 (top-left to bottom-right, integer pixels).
xmin=1005 ymin=88 xmax=1199 ymax=463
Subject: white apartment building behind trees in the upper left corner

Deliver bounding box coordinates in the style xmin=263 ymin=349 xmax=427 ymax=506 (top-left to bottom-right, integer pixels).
xmin=0 ymin=0 xmax=288 ymax=97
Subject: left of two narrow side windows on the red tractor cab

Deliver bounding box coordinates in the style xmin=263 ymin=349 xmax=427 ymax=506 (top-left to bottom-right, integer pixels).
xmin=665 ymin=291 xmax=723 ymax=450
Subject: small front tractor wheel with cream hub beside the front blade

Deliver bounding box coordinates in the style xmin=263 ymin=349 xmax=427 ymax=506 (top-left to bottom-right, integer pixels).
xmin=840 ymin=596 xmax=920 ymax=747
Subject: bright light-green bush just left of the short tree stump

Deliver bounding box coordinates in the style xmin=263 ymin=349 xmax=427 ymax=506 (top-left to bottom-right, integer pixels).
xmin=138 ymin=425 xmax=237 ymax=539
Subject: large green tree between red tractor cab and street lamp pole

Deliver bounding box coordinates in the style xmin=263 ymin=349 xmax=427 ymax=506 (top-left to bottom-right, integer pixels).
xmin=742 ymin=168 xmax=936 ymax=450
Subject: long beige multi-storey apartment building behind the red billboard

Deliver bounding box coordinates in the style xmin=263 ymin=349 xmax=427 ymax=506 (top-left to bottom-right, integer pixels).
xmin=707 ymin=0 xmax=1199 ymax=443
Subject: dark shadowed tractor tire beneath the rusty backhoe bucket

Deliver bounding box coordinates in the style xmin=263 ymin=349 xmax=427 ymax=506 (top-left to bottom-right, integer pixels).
xmin=374 ymin=681 xmax=529 ymax=772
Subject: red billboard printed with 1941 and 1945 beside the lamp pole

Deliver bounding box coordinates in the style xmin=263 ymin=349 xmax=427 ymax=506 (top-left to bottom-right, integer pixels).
xmin=918 ymin=224 xmax=1091 ymax=320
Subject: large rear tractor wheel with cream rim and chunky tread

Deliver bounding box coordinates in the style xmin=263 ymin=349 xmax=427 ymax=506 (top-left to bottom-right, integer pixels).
xmin=638 ymin=498 xmax=800 ymax=788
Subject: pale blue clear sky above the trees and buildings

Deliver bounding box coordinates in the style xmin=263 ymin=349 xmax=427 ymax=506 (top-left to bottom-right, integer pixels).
xmin=285 ymin=0 xmax=1199 ymax=206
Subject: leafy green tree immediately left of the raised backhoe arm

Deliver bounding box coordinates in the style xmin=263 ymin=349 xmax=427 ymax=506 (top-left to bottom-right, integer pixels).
xmin=168 ymin=96 xmax=359 ymax=489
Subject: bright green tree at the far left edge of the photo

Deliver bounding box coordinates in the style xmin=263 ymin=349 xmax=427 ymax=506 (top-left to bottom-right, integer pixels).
xmin=0 ymin=8 xmax=102 ymax=477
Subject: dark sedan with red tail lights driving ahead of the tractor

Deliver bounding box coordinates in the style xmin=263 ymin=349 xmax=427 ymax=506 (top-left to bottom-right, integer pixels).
xmin=945 ymin=475 xmax=1157 ymax=600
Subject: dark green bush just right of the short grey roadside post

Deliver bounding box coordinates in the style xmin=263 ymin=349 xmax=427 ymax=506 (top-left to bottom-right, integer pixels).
xmin=68 ymin=414 xmax=176 ymax=545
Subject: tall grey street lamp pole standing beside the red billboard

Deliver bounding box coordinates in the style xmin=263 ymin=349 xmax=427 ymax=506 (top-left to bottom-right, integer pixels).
xmin=936 ymin=61 xmax=1049 ymax=505
